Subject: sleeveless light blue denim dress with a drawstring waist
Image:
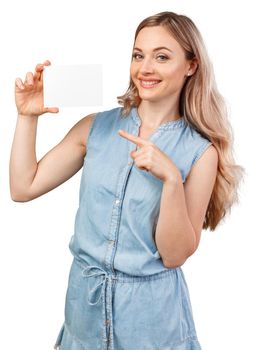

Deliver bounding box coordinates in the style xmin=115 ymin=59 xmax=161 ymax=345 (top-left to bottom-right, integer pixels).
xmin=54 ymin=107 xmax=211 ymax=350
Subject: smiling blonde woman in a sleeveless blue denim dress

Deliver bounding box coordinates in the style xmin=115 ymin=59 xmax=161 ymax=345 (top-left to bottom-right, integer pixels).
xmin=10 ymin=12 xmax=243 ymax=350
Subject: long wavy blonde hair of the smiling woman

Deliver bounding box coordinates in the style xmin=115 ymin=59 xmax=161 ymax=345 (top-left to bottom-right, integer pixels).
xmin=117 ymin=12 xmax=245 ymax=231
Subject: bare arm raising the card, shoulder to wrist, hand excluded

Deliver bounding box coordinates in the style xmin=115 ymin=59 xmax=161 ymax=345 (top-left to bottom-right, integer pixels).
xmin=9 ymin=114 xmax=95 ymax=202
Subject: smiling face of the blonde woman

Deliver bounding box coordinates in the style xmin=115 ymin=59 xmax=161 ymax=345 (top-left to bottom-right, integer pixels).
xmin=130 ymin=26 xmax=194 ymax=102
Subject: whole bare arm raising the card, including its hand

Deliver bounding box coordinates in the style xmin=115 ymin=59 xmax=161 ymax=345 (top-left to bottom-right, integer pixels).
xmin=9 ymin=61 xmax=94 ymax=202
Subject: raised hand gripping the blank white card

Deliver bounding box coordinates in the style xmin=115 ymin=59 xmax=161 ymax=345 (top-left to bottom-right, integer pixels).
xmin=15 ymin=60 xmax=59 ymax=117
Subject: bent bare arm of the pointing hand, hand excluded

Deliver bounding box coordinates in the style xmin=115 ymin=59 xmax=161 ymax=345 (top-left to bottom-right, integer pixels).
xmin=155 ymin=145 xmax=218 ymax=268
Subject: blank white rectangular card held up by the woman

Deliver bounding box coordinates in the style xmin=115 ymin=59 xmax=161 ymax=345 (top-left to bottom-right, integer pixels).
xmin=43 ymin=64 xmax=103 ymax=107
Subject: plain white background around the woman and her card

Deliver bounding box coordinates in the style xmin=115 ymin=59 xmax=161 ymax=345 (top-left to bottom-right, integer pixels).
xmin=0 ymin=0 xmax=253 ymax=350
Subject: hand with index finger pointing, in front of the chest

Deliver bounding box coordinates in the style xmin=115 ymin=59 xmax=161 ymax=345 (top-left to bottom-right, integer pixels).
xmin=118 ymin=130 xmax=181 ymax=182
